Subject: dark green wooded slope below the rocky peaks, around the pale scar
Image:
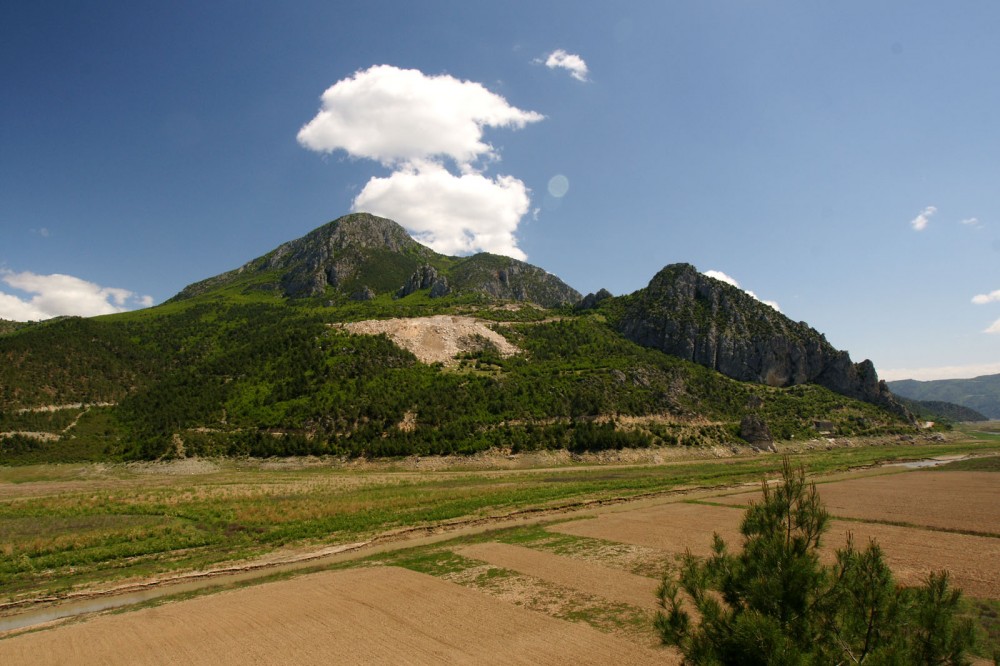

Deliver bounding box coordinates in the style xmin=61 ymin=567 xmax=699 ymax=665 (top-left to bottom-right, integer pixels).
xmin=0 ymin=282 xmax=902 ymax=461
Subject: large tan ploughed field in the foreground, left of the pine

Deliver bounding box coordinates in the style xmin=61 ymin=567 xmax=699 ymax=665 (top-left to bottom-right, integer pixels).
xmin=0 ymin=567 xmax=663 ymax=666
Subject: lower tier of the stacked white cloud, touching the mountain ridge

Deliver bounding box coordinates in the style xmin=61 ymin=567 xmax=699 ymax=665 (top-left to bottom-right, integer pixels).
xmin=353 ymin=162 xmax=531 ymax=260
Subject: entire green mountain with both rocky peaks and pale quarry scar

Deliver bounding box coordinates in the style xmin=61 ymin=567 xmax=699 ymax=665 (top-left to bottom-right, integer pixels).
xmin=0 ymin=214 xmax=913 ymax=462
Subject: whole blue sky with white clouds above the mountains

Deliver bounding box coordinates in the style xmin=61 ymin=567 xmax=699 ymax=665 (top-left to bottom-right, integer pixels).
xmin=0 ymin=0 xmax=1000 ymax=379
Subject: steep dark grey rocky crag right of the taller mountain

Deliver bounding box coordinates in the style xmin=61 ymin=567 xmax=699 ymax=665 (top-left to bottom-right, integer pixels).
xmin=614 ymin=264 xmax=912 ymax=418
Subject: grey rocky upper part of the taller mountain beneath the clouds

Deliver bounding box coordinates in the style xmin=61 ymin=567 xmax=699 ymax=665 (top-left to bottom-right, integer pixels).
xmin=171 ymin=213 xmax=580 ymax=307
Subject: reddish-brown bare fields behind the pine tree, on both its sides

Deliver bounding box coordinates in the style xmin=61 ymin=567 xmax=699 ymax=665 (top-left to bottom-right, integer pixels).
xmin=552 ymin=471 xmax=1000 ymax=599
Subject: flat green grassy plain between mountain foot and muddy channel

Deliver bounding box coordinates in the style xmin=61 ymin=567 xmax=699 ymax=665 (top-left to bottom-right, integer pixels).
xmin=0 ymin=443 xmax=996 ymax=598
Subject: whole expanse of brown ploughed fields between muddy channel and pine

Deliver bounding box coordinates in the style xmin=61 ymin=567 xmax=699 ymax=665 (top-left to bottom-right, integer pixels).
xmin=0 ymin=456 xmax=1000 ymax=664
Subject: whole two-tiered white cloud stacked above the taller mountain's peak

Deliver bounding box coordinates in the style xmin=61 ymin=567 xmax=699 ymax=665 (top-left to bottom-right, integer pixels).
xmin=298 ymin=65 xmax=544 ymax=259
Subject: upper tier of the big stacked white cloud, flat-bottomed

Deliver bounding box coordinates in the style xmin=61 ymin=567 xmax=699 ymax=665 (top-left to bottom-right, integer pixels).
xmin=298 ymin=65 xmax=544 ymax=169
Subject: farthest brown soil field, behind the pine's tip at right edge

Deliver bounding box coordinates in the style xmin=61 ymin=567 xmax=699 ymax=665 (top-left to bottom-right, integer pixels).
xmin=719 ymin=471 xmax=1000 ymax=535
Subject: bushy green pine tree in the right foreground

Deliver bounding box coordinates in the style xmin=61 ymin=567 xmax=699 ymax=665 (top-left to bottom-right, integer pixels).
xmin=656 ymin=459 xmax=975 ymax=665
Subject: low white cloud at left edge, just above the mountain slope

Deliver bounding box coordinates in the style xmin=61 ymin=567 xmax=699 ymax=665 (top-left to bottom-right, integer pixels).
xmin=0 ymin=271 xmax=153 ymax=321
